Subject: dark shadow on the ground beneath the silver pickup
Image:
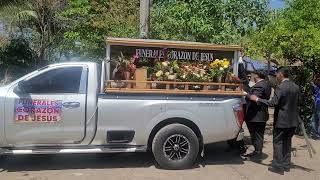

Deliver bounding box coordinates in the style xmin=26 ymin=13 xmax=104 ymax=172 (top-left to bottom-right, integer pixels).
xmin=0 ymin=143 xmax=243 ymax=172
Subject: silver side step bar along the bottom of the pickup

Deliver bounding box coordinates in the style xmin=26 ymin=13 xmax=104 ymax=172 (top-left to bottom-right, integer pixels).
xmin=0 ymin=146 xmax=147 ymax=155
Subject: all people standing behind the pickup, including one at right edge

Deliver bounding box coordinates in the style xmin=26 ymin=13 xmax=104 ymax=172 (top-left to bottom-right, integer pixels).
xmin=239 ymin=61 xmax=320 ymax=175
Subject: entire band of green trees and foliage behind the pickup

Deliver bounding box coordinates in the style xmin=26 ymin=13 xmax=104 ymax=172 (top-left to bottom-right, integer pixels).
xmin=0 ymin=0 xmax=320 ymax=129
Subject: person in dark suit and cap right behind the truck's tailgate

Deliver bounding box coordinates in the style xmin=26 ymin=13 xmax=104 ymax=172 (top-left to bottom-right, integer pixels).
xmin=245 ymin=70 xmax=271 ymax=160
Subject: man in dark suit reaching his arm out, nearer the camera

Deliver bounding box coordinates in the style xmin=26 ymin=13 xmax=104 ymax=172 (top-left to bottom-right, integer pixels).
xmin=250 ymin=67 xmax=299 ymax=174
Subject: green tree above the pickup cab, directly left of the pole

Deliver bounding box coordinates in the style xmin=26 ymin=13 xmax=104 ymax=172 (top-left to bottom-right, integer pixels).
xmin=59 ymin=0 xmax=139 ymax=58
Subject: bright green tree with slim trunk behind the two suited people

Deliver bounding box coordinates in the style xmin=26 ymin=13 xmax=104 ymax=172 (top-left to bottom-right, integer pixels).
xmin=246 ymin=0 xmax=320 ymax=129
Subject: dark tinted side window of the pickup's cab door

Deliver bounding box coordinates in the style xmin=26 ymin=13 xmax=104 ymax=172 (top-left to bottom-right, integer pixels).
xmin=23 ymin=67 xmax=83 ymax=94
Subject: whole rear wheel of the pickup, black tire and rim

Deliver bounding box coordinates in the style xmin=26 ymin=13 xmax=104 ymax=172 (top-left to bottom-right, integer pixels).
xmin=152 ymin=124 xmax=199 ymax=169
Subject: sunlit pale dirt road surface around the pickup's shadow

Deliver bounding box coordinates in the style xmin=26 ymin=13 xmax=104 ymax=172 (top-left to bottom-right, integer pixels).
xmin=0 ymin=126 xmax=320 ymax=180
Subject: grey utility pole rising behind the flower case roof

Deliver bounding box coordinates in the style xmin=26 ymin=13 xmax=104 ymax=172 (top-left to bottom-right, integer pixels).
xmin=140 ymin=0 xmax=150 ymax=39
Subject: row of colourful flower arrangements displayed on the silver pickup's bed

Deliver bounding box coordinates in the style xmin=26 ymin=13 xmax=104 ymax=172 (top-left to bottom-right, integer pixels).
xmin=110 ymin=52 xmax=232 ymax=85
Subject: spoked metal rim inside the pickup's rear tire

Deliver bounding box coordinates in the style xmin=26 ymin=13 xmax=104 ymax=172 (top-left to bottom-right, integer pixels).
xmin=163 ymin=134 xmax=190 ymax=161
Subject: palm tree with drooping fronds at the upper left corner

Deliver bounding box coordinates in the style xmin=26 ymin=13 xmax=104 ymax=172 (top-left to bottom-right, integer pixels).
xmin=2 ymin=0 xmax=63 ymax=65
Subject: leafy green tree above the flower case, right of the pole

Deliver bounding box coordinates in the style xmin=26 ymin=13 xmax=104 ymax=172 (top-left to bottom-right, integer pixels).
xmin=151 ymin=0 xmax=270 ymax=44
